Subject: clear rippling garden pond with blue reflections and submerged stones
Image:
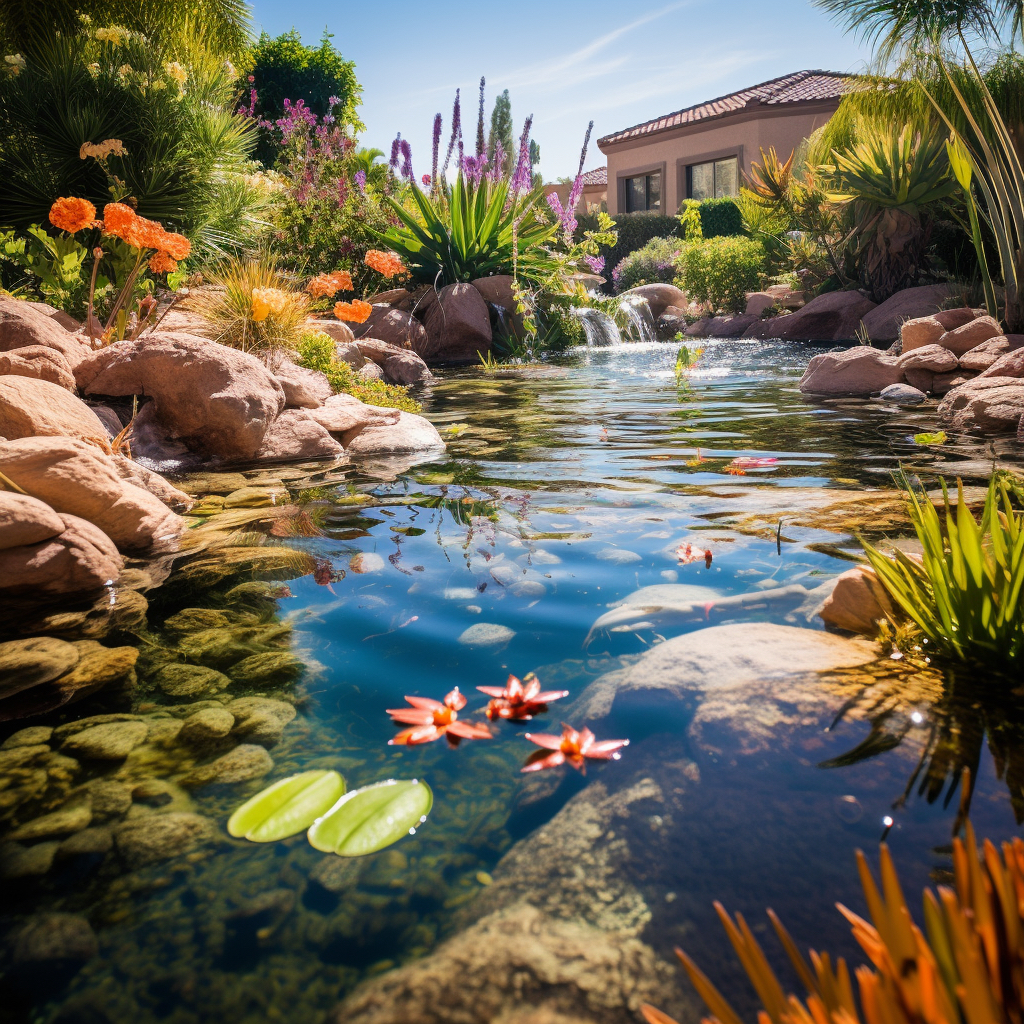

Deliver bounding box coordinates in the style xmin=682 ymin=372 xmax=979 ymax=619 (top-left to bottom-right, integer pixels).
xmin=0 ymin=342 xmax=1024 ymax=1024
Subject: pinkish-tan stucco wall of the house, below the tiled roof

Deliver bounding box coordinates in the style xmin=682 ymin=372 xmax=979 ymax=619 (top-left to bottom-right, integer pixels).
xmin=601 ymin=100 xmax=839 ymax=216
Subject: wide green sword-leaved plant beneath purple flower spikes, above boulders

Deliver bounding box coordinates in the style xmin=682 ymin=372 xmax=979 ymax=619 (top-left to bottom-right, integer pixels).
xmin=381 ymin=173 xmax=556 ymax=287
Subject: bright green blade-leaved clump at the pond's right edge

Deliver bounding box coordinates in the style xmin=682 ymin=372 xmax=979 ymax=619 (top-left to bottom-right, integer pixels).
xmin=862 ymin=479 xmax=1024 ymax=671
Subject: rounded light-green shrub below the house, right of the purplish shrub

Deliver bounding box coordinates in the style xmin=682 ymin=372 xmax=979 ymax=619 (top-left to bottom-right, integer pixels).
xmin=677 ymin=237 xmax=765 ymax=312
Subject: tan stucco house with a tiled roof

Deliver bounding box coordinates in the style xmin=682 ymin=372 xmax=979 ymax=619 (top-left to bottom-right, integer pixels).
xmin=597 ymin=71 xmax=856 ymax=215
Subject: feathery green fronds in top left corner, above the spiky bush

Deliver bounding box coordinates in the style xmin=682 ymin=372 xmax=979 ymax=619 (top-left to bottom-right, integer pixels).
xmin=0 ymin=0 xmax=250 ymax=57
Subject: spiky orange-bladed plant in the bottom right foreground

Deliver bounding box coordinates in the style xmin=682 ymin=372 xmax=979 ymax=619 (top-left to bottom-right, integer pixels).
xmin=641 ymin=806 xmax=1024 ymax=1024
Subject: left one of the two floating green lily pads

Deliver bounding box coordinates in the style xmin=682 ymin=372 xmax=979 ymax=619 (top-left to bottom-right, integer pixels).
xmin=227 ymin=771 xmax=345 ymax=843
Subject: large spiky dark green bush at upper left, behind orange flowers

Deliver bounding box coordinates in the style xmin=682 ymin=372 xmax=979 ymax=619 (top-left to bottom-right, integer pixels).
xmin=0 ymin=35 xmax=254 ymax=243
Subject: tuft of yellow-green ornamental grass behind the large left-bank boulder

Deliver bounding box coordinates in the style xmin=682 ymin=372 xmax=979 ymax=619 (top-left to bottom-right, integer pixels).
xmin=188 ymin=257 xmax=309 ymax=352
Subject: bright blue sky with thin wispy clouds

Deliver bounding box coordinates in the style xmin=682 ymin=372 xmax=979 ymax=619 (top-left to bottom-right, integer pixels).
xmin=247 ymin=0 xmax=868 ymax=180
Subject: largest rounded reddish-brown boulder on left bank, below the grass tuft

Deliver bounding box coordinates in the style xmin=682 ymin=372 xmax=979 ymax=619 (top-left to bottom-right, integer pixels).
xmin=74 ymin=333 xmax=285 ymax=459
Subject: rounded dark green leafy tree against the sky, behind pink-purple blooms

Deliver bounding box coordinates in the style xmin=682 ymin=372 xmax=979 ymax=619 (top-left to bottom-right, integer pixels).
xmin=243 ymin=29 xmax=366 ymax=166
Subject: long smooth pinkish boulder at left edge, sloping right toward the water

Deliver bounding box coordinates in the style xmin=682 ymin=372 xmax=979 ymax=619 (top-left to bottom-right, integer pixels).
xmin=0 ymin=437 xmax=187 ymax=554
